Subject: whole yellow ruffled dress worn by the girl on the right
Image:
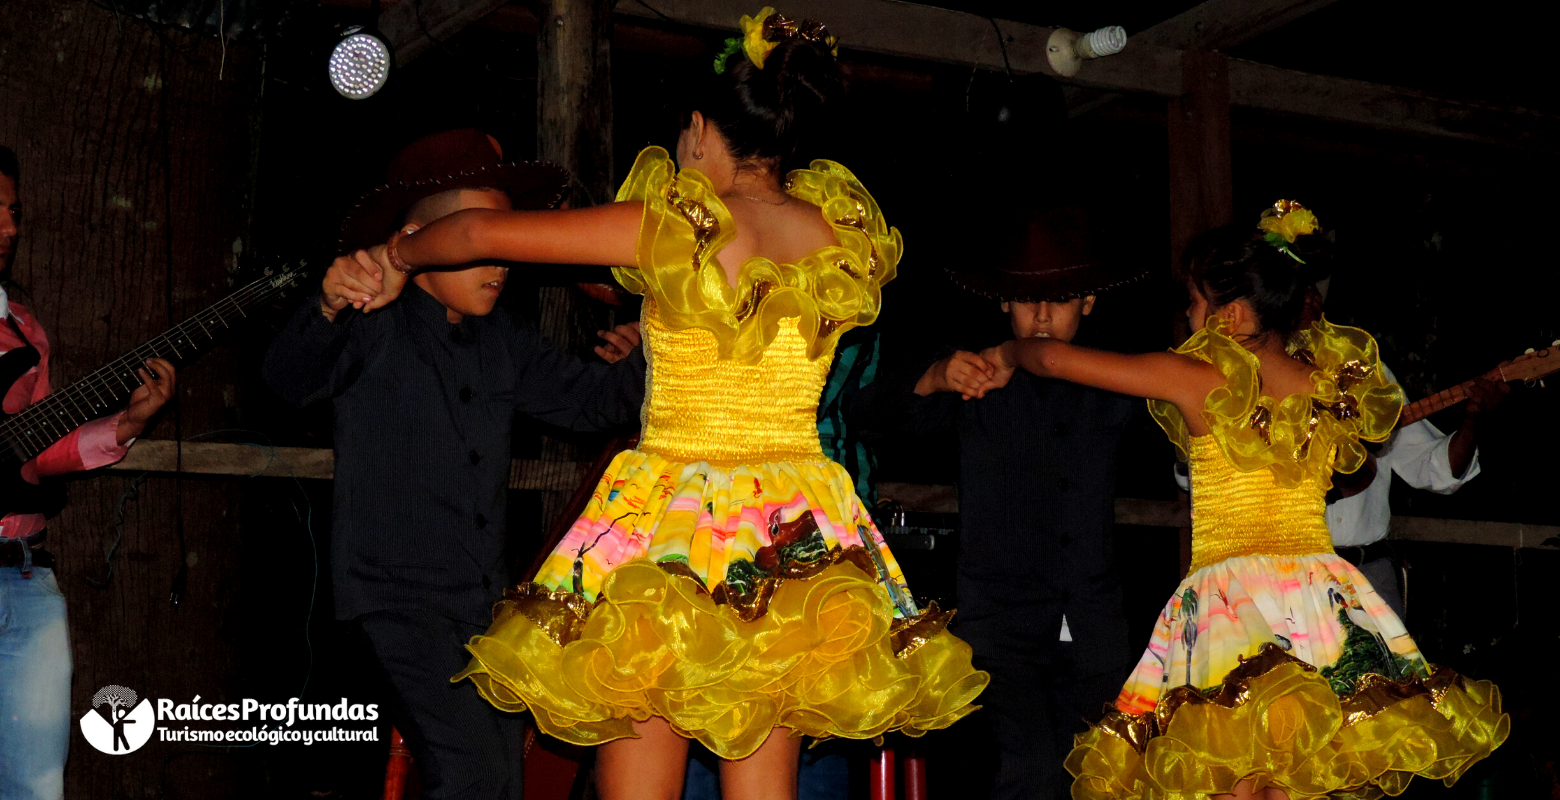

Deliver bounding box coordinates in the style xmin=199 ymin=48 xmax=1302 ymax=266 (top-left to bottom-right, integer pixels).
xmin=1067 ymin=318 xmax=1510 ymax=800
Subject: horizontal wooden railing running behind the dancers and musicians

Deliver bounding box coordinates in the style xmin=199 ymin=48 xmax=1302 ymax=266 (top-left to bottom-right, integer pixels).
xmin=109 ymin=440 xmax=1560 ymax=550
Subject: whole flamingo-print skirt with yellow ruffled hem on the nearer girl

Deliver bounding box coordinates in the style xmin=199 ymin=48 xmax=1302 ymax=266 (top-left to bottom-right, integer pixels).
xmin=454 ymin=451 xmax=989 ymax=758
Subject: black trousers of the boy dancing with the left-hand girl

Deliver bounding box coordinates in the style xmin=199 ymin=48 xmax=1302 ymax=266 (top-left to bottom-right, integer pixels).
xmin=357 ymin=610 xmax=526 ymax=800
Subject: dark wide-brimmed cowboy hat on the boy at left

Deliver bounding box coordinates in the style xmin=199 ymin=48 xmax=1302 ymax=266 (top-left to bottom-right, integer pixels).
xmin=339 ymin=128 xmax=569 ymax=253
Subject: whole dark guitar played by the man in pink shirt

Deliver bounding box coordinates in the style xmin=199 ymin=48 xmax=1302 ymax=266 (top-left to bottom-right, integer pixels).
xmin=0 ymin=262 xmax=307 ymax=516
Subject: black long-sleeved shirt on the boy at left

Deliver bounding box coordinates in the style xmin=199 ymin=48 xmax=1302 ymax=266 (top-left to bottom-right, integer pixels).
xmin=265 ymin=284 xmax=644 ymax=624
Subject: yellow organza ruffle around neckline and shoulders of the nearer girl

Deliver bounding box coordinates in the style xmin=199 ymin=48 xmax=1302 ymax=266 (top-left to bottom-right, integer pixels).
xmin=613 ymin=147 xmax=903 ymax=363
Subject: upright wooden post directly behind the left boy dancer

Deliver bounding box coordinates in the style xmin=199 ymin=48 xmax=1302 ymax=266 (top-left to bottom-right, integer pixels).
xmin=534 ymin=0 xmax=613 ymax=529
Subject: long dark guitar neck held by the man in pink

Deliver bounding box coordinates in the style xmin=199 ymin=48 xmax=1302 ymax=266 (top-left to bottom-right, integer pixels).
xmin=0 ymin=270 xmax=300 ymax=462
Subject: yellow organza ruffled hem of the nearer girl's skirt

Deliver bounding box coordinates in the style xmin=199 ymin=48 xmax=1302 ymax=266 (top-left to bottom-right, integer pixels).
xmin=452 ymin=549 xmax=989 ymax=758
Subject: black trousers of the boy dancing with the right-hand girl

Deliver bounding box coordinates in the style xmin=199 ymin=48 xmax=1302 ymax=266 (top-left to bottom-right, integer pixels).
xmin=955 ymin=574 xmax=1131 ymax=800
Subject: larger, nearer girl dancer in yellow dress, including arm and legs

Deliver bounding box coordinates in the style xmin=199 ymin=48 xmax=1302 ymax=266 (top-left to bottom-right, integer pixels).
xmin=332 ymin=8 xmax=987 ymax=798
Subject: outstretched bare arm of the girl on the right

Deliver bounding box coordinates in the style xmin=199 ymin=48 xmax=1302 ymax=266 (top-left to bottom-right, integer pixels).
xmin=981 ymin=338 xmax=1225 ymax=427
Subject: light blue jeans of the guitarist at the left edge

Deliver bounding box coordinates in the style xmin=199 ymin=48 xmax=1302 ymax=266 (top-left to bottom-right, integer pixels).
xmin=0 ymin=566 xmax=70 ymax=800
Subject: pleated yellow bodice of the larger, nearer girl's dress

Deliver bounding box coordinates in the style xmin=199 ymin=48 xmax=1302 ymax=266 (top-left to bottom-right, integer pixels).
xmin=640 ymin=303 xmax=833 ymax=466
